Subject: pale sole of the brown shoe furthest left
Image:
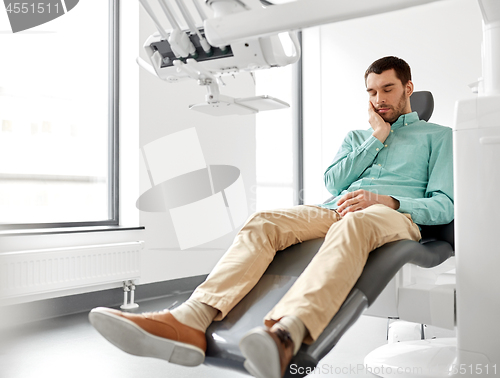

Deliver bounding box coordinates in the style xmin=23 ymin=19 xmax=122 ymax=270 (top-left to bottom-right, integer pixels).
xmin=89 ymin=310 xmax=205 ymax=366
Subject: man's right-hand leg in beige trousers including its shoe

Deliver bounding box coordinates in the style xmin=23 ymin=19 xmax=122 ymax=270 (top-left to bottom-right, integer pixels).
xmin=240 ymin=205 xmax=420 ymax=378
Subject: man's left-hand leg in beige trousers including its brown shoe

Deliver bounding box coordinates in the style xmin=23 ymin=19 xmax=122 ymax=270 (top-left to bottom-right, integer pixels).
xmin=89 ymin=206 xmax=340 ymax=366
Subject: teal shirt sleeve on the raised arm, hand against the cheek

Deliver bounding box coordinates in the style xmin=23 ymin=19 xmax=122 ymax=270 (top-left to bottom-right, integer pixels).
xmin=324 ymin=131 xmax=384 ymax=196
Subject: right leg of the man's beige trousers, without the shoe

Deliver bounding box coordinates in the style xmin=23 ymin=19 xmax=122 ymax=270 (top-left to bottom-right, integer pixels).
xmin=265 ymin=205 xmax=421 ymax=342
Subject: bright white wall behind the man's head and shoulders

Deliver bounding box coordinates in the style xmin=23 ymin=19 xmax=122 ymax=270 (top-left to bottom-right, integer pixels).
xmin=303 ymin=0 xmax=482 ymax=203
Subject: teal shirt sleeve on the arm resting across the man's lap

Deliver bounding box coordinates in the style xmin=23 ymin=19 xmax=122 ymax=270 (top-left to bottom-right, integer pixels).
xmin=392 ymin=129 xmax=454 ymax=225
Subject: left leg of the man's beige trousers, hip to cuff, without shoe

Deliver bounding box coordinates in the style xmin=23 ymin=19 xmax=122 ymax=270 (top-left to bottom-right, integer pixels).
xmin=191 ymin=206 xmax=340 ymax=320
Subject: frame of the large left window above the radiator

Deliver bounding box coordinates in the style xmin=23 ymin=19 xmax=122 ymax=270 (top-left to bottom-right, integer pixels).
xmin=0 ymin=0 xmax=120 ymax=231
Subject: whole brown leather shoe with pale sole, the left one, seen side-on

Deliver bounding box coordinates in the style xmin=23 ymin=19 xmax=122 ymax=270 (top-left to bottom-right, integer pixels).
xmin=89 ymin=307 xmax=207 ymax=366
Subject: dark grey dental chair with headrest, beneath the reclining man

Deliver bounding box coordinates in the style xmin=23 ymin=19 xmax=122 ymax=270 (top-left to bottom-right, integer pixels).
xmin=205 ymin=92 xmax=454 ymax=378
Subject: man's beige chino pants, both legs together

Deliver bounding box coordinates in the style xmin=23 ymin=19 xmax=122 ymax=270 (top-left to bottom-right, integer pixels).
xmin=192 ymin=205 xmax=421 ymax=342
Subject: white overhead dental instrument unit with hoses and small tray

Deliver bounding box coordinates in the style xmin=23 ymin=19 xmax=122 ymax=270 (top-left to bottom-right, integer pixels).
xmin=138 ymin=0 xmax=300 ymax=116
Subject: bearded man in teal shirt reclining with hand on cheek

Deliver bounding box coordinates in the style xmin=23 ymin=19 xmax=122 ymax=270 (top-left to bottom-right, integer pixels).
xmin=89 ymin=57 xmax=453 ymax=378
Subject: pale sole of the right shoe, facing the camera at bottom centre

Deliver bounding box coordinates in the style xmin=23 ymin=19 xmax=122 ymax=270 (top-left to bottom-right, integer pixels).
xmin=240 ymin=328 xmax=281 ymax=378
